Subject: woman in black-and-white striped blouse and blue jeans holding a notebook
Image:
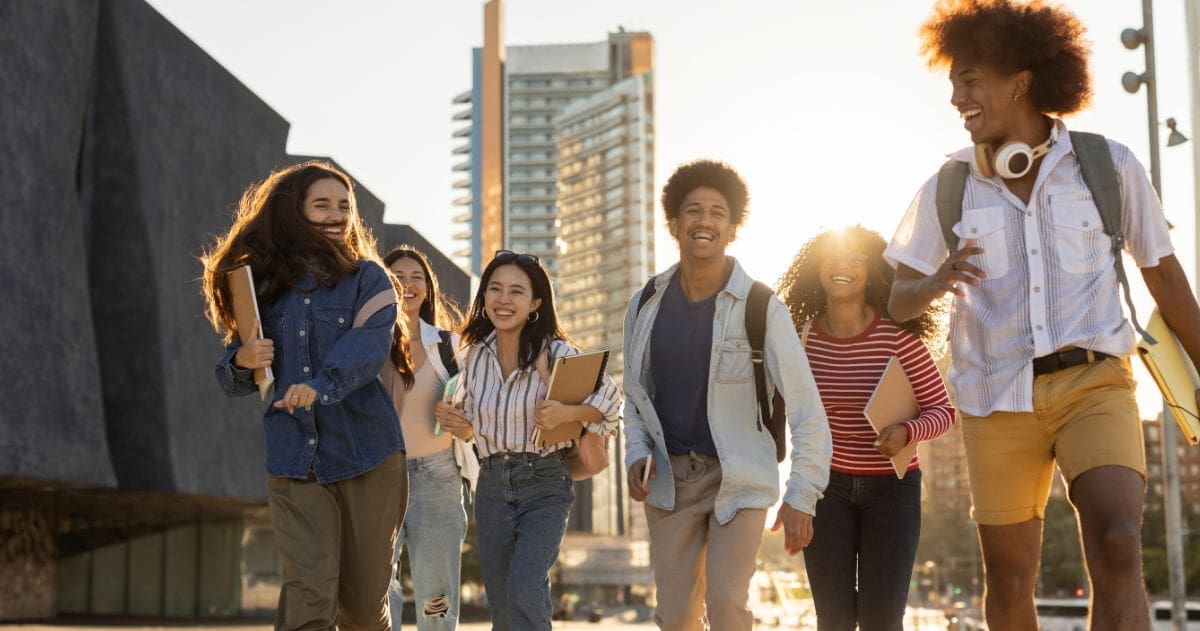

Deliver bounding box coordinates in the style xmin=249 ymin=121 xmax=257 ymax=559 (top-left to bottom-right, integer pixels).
xmin=434 ymin=250 xmax=620 ymax=630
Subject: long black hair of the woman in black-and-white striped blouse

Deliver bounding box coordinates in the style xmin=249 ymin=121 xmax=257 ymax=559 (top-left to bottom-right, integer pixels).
xmin=462 ymin=252 xmax=570 ymax=368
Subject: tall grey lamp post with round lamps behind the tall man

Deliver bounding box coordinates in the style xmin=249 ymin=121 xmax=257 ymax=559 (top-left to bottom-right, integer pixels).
xmin=1117 ymin=0 xmax=1187 ymax=631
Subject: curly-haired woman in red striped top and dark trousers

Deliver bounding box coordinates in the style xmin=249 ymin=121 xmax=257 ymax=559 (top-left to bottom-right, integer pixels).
xmin=779 ymin=226 xmax=954 ymax=631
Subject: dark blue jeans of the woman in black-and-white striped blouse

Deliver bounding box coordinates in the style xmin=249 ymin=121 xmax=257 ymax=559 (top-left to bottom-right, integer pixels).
xmin=475 ymin=451 xmax=575 ymax=631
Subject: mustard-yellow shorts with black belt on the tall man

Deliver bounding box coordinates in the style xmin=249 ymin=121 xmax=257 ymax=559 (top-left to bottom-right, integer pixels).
xmin=962 ymin=357 xmax=1146 ymax=525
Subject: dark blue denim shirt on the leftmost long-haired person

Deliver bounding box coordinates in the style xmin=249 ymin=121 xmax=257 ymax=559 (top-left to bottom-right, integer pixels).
xmin=216 ymin=260 xmax=404 ymax=483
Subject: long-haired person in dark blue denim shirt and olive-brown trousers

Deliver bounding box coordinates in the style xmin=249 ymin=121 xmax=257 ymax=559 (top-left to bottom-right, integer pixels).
xmin=202 ymin=161 xmax=413 ymax=631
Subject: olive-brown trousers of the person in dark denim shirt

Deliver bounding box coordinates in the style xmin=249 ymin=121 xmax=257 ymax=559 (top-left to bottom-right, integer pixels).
xmin=266 ymin=451 xmax=408 ymax=631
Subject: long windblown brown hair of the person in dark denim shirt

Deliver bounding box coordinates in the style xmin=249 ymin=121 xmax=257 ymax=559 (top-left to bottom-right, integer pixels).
xmin=200 ymin=161 xmax=379 ymax=343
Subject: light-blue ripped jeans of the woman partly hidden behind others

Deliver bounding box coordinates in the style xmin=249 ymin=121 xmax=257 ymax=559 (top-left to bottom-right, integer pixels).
xmin=388 ymin=449 xmax=467 ymax=631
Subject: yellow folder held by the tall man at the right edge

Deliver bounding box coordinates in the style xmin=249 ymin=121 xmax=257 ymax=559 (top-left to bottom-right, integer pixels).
xmin=1138 ymin=308 xmax=1200 ymax=445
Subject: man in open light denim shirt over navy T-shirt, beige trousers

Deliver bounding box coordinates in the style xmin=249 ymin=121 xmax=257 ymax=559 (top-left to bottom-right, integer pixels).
xmin=624 ymin=161 xmax=832 ymax=631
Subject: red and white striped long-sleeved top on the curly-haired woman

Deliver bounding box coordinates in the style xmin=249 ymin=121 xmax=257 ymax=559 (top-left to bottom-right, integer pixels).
xmin=804 ymin=313 xmax=954 ymax=475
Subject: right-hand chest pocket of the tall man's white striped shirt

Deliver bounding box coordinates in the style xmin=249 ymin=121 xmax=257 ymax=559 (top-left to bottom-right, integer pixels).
xmin=1050 ymin=191 xmax=1111 ymax=274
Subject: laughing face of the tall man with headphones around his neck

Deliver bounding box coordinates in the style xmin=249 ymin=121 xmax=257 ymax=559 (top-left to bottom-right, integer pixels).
xmin=950 ymin=60 xmax=1031 ymax=148
